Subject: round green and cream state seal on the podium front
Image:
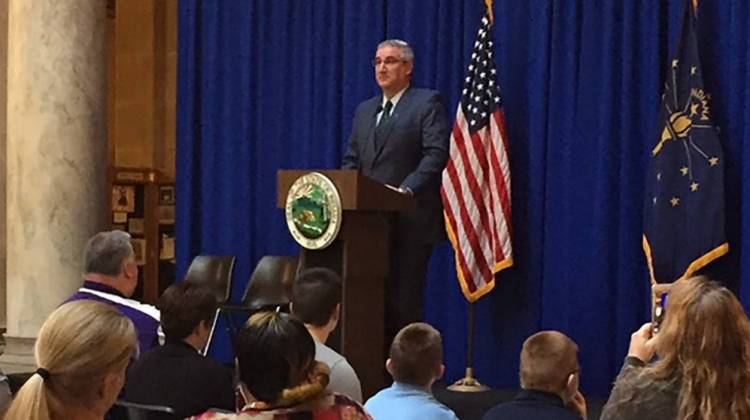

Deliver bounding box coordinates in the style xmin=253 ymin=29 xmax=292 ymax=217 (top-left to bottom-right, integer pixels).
xmin=285 ymin=172 xmax=343 ymax=249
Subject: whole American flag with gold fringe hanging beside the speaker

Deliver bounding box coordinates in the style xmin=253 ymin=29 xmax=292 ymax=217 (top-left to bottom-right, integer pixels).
xmin=441 ymin=9 xmax=513 ymax=302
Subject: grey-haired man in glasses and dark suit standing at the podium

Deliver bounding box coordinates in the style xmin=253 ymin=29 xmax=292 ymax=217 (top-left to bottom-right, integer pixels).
xmin=342 ymin=39 xmax=450 ymax=339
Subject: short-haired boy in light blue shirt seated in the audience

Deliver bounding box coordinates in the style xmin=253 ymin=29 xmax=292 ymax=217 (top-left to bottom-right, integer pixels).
xmin=365 ymin=322 xmax=457 ymax=420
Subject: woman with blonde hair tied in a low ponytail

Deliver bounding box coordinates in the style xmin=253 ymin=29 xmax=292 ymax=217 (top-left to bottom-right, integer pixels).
xmin=5 ymin=302 xmax=138 ymax=420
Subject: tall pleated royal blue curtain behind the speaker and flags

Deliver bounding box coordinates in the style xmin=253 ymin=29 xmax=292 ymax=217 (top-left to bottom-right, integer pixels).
xmin=177 ymin=0 xmax=750 ymax=395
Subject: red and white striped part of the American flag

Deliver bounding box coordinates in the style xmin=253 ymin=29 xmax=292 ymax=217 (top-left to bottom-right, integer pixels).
xmin=441 ymin=104 xmax=513 ymax=302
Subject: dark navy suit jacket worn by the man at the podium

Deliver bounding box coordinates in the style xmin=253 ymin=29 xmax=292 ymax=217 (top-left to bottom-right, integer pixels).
xmin=342 ymin=87 xmax=450 ymax=243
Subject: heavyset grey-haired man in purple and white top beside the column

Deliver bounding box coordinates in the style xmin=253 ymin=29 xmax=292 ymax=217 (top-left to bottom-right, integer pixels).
xmin=66 ymin=230 xmax=159 ymax=352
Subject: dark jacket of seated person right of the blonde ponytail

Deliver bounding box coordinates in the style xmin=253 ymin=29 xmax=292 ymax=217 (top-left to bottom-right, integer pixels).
xmin=124 ymin=341 xmax=235 ymax=418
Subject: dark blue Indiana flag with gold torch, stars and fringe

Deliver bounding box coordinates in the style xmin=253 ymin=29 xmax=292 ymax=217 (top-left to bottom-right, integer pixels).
xmin=643 ymin=2 xmax=729 ymax=283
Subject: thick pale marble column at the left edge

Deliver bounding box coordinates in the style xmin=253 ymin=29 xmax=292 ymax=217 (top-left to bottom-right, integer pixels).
xmin=0 ymin=0 xmax=108 ymax=371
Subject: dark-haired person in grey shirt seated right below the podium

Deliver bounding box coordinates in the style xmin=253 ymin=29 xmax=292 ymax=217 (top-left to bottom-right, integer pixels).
xmin=291 ymin=268 xmax=362 ymax=403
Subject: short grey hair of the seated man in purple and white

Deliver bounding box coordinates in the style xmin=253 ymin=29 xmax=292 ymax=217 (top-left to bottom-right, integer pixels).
xmin=83 ymin=230 xmax=133 ymax=276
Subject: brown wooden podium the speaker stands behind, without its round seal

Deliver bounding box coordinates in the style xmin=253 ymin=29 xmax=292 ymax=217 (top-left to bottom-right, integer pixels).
xmin=278 ymin=170 xmax=415 ymax=399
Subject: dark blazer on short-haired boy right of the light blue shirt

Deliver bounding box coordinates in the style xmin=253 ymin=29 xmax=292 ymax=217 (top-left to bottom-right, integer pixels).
xmin=483 ymin=389 xmax=581 ymax=420
